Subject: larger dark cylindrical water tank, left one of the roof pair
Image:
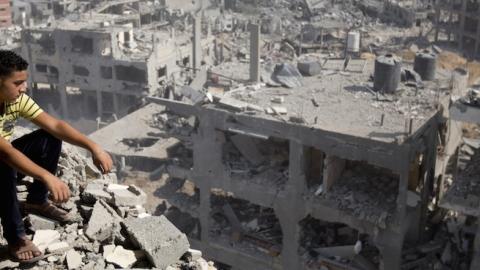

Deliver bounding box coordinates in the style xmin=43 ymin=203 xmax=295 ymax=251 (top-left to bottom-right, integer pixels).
xmin=373 ymin=54 xmax=402 ymax=93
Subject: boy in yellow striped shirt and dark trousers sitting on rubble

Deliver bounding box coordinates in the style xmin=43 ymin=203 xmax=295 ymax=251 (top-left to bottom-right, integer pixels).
xmin=0 ymin=50 xmax=112 ymax=262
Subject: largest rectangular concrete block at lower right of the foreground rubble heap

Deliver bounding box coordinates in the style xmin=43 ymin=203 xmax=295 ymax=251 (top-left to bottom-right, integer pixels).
xmin=122 ymin=216 xmax=190 ymax=269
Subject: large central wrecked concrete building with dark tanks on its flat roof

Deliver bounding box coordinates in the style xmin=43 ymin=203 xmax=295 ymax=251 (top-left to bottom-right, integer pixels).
xmin=87 ymin=16 xmax=480 ymax=269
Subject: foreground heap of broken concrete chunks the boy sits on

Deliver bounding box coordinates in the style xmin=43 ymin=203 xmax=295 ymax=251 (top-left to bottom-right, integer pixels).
xmin=0 ymin=128 xmax=216 ymax=270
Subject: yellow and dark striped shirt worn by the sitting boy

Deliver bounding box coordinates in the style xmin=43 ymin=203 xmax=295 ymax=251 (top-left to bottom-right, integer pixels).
xmin=0 ymin=94 xmax=43 ymax=141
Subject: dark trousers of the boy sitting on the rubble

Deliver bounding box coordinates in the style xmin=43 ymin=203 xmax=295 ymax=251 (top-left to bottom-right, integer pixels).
xmin=0 ymin=129 xmax=62 ymax=244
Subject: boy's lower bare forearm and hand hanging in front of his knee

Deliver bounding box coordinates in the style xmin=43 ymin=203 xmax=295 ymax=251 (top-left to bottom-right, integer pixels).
xmin=0 ymin=136 xmax=70 ymax=202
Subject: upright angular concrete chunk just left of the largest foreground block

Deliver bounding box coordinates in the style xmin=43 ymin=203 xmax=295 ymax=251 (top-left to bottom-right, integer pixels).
xmin=85 ymin=200 xmax=121 ymax=242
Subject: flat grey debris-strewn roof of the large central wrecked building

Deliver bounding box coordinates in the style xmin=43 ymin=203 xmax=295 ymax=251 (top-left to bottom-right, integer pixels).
xmin=206 ymin=59 xmax=449 ymax=142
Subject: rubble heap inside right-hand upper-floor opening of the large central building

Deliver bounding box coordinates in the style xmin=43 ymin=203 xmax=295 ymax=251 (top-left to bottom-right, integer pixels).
xmin=324 ymin=163 xmax=398 ymax=228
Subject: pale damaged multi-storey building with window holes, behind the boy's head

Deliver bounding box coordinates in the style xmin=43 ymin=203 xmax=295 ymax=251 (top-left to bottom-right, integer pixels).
xmin=22 ymin=10 xmax=212 ymax=132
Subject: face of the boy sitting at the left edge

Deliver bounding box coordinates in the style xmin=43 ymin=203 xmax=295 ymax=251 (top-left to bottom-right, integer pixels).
xmin=0 ymin=70 xmax=28 ymax=102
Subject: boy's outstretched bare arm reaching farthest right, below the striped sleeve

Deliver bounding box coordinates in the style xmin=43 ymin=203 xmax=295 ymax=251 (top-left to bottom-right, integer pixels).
xmin=32 ymin=112 xmax=113 ymax=173
